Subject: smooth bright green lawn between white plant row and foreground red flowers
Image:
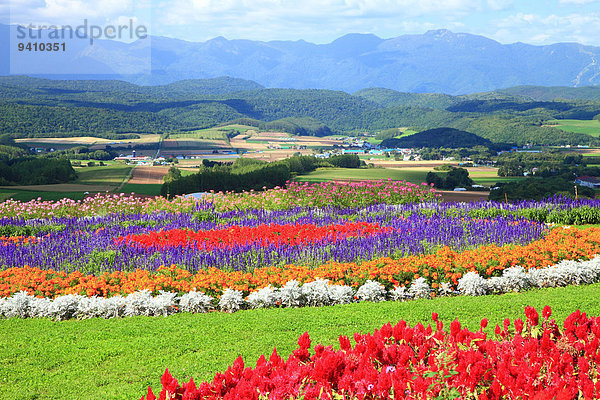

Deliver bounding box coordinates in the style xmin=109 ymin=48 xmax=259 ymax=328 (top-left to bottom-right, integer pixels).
xmin=0 ymin=284 xmax=600 ymax=400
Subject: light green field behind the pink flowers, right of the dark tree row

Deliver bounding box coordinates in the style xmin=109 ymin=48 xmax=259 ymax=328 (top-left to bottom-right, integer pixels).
xmin=295 ymin=168 xmax=427 ymax=183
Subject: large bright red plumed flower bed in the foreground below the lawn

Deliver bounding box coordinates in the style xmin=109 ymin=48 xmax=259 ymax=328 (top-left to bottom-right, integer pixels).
xmin=142 ymin=306 xmax=600 ymax=400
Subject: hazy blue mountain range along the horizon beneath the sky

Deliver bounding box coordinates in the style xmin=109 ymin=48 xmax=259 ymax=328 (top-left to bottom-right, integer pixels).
xmin=0 ymin=25 xmax=600 ymax=95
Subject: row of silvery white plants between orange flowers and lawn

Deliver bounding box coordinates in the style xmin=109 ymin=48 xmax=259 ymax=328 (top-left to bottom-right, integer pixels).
xmin=0 ymin=256 xmax=600 ymax=320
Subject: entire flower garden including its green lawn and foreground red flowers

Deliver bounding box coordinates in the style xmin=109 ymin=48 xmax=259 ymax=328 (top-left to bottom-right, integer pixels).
xmin=0 ymin=184 xmax=600 ymax=399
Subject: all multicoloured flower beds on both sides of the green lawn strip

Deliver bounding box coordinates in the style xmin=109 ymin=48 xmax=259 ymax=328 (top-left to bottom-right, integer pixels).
xmin=0 ymin=181 xmax=600 ymax=399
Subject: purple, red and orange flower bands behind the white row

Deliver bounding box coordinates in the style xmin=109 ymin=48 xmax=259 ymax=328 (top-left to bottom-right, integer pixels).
xmin=0 ymin=181 xmax=600 ymax=296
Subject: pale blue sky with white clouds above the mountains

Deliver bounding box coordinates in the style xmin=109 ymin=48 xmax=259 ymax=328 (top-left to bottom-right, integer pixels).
xmin=0 ymin=0 xmax=600 ymax=46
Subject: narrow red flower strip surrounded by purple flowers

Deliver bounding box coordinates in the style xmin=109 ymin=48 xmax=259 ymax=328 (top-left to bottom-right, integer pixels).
xmin=115 ymin=222 xmax=391 ymax=250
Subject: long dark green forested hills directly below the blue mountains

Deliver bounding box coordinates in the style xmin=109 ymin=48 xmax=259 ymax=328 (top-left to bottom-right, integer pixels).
xmin=0 ymin=77 xmax=600 ymax=145
